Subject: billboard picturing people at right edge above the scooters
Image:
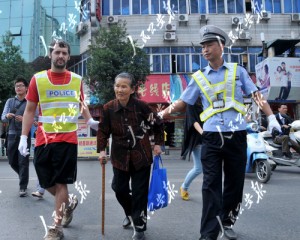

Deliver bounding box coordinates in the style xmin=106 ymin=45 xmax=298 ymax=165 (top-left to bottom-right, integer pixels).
xmin=255 ymin=57 xmax=300 ymax=102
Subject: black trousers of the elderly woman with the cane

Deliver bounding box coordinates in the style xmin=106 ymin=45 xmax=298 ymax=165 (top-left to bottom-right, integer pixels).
xmin=112 ymin=163 xmax=151 ymax=232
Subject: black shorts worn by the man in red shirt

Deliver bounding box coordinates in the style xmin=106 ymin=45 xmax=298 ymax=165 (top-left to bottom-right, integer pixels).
xmin=33 ymin=142 xmax=77 ymax=188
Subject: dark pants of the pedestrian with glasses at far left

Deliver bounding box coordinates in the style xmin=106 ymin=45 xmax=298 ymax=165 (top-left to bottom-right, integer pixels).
xmin=7 ymin=134 xmax=31 ymax=189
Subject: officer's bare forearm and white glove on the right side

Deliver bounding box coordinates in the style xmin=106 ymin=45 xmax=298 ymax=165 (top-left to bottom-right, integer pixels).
xmin=252 ymin=91 xmax=281 ymax=132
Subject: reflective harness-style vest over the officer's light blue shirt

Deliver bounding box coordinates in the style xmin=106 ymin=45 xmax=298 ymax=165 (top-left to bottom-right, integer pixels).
xmin=192 ymin=63 xmax=246 ymax=122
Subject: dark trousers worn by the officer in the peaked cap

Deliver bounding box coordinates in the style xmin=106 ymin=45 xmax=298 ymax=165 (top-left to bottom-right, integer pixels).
xmin=200 ymin=131 xmax=247 ymax=239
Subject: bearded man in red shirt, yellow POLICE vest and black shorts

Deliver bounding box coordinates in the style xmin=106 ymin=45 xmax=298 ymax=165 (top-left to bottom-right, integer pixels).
xmin=19 ymin=40 xmax=99 ymax=240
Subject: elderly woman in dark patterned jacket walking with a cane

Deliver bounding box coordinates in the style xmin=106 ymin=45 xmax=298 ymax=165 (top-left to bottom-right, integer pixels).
xmin=97 ymin=73 xmax=164 ymax=240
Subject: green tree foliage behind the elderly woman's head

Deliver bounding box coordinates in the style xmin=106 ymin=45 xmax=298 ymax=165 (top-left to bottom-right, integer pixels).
xmin=86 ymin=22 xmax=150 ymax=103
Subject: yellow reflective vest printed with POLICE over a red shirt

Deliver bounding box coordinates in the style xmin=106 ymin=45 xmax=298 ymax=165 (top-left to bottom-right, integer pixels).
xmin=35 ymin=71 xmax=81 ymax=133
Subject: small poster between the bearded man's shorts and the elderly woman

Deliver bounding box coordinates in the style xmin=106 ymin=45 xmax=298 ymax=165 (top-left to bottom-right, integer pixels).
xmin=78 ymin=137 xmax=99 ymax=157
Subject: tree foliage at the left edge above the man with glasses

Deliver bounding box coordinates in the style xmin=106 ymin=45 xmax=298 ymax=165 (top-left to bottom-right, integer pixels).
xmin=0 ymin=33 xmax=33 ymax=113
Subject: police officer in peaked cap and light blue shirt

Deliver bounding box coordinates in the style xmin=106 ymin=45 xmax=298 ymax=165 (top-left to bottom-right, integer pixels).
xmin=159 ymin=25 xmax=280 ymax=240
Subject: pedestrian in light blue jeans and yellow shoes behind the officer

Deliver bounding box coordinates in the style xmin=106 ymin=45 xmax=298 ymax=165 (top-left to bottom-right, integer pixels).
xmin=180 ymin=98 xmax=203 ymax=201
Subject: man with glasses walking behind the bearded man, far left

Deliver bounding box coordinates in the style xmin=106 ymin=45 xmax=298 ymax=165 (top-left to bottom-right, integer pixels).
xmin=1 ymin=77 xmax=31 ymax=197
